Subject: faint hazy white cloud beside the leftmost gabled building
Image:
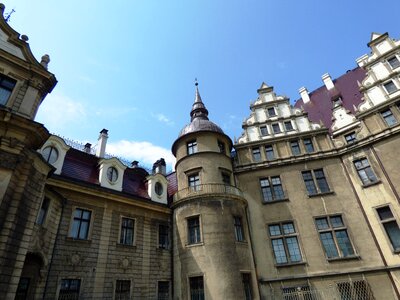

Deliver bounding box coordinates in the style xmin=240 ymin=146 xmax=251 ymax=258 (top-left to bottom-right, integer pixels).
xmin=36 ymin=93 xmax=87 ymax=132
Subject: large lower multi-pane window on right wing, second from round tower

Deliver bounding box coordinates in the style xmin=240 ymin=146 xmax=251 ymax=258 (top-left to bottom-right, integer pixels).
xmin=315 ymin=215 xmax=354 ymax=259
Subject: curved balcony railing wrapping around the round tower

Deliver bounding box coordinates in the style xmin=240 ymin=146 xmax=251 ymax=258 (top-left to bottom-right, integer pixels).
xmin=174 ymin=183 xmax=243 ymax=201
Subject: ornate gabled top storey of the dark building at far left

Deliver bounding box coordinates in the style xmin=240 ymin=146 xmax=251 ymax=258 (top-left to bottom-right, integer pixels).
xmin=0 ymin=4 xmax=57 ymax=119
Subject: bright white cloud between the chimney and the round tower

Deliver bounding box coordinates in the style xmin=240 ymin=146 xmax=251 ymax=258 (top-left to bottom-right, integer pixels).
xmin=106 ymin=140 xmax=175 ymax=170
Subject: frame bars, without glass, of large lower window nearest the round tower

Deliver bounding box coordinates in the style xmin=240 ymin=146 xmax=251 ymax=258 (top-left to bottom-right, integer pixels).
xmin=267 ymin=220 xmax=304 ymax=266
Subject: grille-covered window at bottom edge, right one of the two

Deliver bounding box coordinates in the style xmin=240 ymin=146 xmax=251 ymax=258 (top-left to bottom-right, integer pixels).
xmin=336 ymin=280 xmax=375 ymax=300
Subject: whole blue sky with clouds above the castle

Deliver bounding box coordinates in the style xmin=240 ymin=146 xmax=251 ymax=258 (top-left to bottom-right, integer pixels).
xmin=3 ymin=0 xmax=400 ymax=166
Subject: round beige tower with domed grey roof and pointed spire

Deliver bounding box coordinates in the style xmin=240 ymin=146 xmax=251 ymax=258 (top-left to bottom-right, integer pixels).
xmin=172 ymin=83 xmax=257 ymax=299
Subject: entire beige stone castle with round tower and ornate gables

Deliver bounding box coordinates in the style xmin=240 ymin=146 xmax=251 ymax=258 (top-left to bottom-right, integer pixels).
xmin=0 ymin=5 xmax=400 ymax=300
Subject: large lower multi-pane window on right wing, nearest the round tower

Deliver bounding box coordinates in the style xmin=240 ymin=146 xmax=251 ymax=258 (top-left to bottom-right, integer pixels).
xmin=268 ymin=222 xmax=302 ymax=264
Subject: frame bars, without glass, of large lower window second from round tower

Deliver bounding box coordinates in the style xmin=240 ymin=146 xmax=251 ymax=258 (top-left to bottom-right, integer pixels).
xmin=314 ymin=214 xmax=358 ymax=261
